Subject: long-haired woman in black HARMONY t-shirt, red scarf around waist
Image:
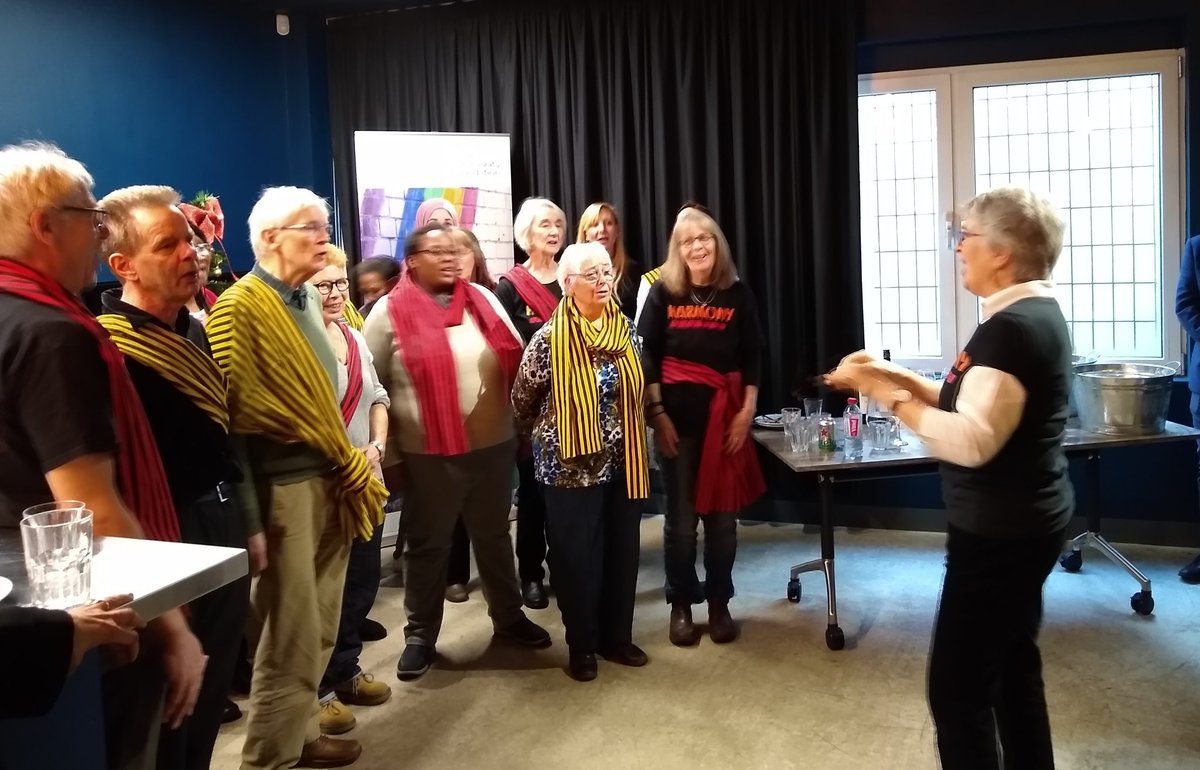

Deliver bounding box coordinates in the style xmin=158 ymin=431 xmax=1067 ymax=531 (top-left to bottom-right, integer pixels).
xmin=638 ymin=207 xmax=766 ymax=646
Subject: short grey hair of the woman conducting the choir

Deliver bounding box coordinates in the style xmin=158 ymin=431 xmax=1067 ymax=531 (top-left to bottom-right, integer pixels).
xmin=962 ymin=187 xmax=1064 ymax=282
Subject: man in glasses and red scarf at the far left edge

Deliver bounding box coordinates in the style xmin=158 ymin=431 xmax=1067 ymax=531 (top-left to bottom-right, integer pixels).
xmin=0 ymin=144 xmax=205 ymax=766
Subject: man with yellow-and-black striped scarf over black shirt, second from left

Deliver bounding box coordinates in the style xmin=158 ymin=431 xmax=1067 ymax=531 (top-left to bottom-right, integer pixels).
xmin=100 ymin=186 xmax=266 ymax=770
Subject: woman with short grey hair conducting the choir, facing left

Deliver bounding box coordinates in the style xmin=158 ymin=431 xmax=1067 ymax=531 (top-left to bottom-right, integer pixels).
xmin=828 ymin=188 xmax=1074 ymax=770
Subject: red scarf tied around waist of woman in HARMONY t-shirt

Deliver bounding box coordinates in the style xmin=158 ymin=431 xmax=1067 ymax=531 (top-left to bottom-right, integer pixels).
xmin=662 ymin=357 xmax=767 ymax=513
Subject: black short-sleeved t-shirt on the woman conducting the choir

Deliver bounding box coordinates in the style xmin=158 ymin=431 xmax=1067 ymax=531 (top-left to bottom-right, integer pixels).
xmin=938 ymin=296 xmax=1075 ymax=539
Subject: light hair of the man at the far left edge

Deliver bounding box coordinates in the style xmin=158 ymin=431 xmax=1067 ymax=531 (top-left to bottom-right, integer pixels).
xmin=0 ymin=142 xmax=94 ymax=257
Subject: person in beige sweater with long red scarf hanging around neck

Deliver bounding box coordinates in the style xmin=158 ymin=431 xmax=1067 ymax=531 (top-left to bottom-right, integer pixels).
xmin=364 ymin=224 xmax=550 ymax=680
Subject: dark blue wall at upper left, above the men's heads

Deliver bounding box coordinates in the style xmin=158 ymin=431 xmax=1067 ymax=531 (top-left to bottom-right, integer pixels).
xmin=0 ymin=0 xmax=332 ymax=270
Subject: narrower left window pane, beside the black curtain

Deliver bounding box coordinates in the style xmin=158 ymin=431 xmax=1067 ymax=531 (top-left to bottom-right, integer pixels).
xmin=858 ymin=91 xmax=945 ymax=359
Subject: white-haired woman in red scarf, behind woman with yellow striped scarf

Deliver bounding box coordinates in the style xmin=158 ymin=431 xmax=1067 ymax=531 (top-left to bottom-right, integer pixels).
xmin=496 ymin=198 xmax=566 ymax=609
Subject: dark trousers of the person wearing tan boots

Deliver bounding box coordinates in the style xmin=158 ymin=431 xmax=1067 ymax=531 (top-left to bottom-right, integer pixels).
xmin=318 ymin=524 xmax=383 ymax=697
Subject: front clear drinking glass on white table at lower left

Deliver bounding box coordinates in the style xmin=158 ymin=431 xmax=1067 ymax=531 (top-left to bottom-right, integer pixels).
xmin=20 ymin=506 xmax=92 ymax=609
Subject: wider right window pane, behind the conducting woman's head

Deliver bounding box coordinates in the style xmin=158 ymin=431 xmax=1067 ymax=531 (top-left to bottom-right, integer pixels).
xmin=971 ymin=74 xmax=1164 ymax=357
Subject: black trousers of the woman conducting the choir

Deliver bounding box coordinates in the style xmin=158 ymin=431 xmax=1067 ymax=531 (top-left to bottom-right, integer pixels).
xmin=929 ymin=525 xmax=1066 ymax=770
